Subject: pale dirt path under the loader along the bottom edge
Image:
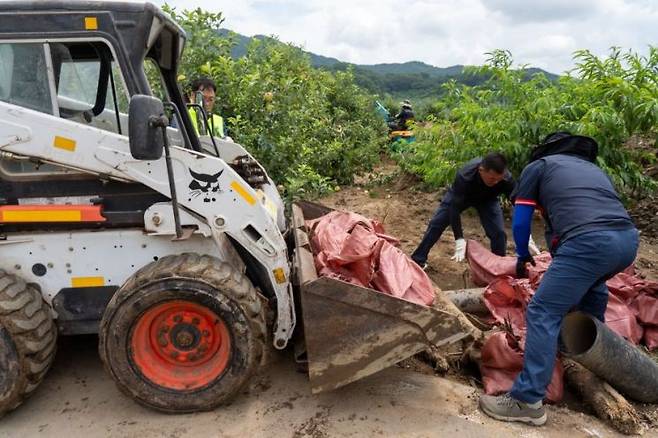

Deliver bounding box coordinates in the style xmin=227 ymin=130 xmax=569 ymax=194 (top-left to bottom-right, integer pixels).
xmin=0 ymin=336 xmax=636 ymax=438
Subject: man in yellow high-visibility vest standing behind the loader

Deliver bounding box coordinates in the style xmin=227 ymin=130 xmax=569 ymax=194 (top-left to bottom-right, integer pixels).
xmin=188 ymin=77 xmax=226 ymax=138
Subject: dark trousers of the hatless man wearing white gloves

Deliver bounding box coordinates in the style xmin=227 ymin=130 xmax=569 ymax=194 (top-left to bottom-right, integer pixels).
xmin=411 ymin=191 xmax=507 ymax=266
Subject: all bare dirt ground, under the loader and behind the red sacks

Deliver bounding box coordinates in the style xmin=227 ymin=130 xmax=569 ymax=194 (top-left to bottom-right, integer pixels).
xmin=0 ymin=165 xmax=658 ymax=438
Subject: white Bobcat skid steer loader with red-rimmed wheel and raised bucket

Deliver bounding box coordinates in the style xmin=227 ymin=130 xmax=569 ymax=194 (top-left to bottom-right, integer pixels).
xmin=0 ymin=1 xmax=466 ymax=415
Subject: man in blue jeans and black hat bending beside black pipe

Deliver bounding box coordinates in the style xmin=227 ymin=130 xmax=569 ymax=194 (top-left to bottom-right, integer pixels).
xmin=480 ymin=132 xmax=638 ymax=425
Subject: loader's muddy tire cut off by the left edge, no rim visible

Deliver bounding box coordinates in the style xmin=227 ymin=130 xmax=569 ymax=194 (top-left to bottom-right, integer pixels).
xmin=0 ymin=271 xmax=57 ymax=417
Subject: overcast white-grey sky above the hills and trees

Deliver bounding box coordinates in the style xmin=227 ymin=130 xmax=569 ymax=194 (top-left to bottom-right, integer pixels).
xmin=151 ymin=0 xmax=658 ymax=73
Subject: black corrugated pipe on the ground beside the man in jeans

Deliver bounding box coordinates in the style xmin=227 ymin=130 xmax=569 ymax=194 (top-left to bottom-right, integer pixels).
xmin=560 ymin=312 xmax=658 ymax=403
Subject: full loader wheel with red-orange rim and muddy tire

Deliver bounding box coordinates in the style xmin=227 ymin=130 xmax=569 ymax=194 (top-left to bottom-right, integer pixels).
xmin=99 ymin=254 xmax=267 ymax=413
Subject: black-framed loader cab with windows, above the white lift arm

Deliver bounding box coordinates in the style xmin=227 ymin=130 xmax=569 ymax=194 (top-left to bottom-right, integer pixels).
xmin=0 ymin=1 xmax=201 ymax=151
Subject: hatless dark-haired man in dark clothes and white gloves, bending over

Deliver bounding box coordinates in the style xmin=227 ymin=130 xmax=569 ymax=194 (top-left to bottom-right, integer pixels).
xmin=411 ymin=152 xmax=539 ymax=269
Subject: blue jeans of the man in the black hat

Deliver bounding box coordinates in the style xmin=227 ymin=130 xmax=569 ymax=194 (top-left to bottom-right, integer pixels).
xmin=511 ymin=228 xmax=638 ymax=403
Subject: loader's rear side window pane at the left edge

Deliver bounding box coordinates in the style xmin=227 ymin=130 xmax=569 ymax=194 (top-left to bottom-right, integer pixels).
xmin=0 ymin=43 xmax=53 ymax=114
